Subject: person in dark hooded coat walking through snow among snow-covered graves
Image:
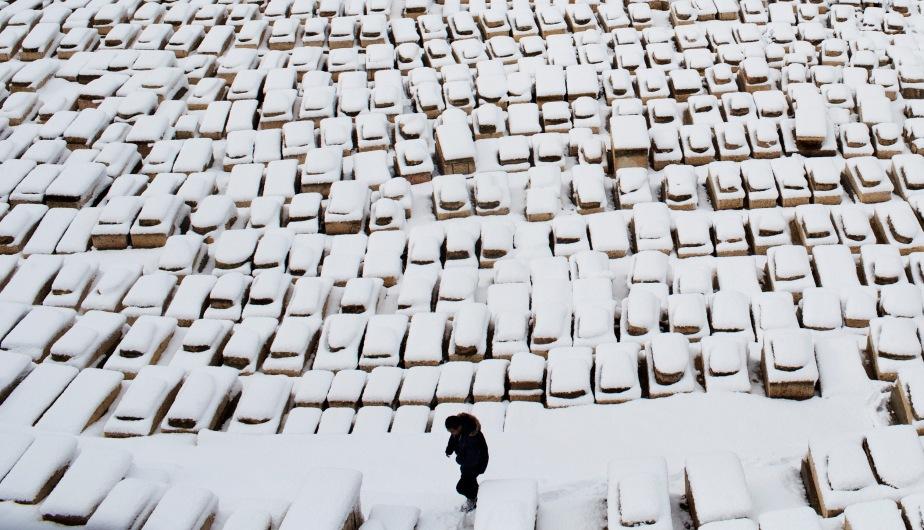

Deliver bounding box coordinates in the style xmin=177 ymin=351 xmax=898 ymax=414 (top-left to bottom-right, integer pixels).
xmin=446 ymin=412 xmax=488 ymax=512
